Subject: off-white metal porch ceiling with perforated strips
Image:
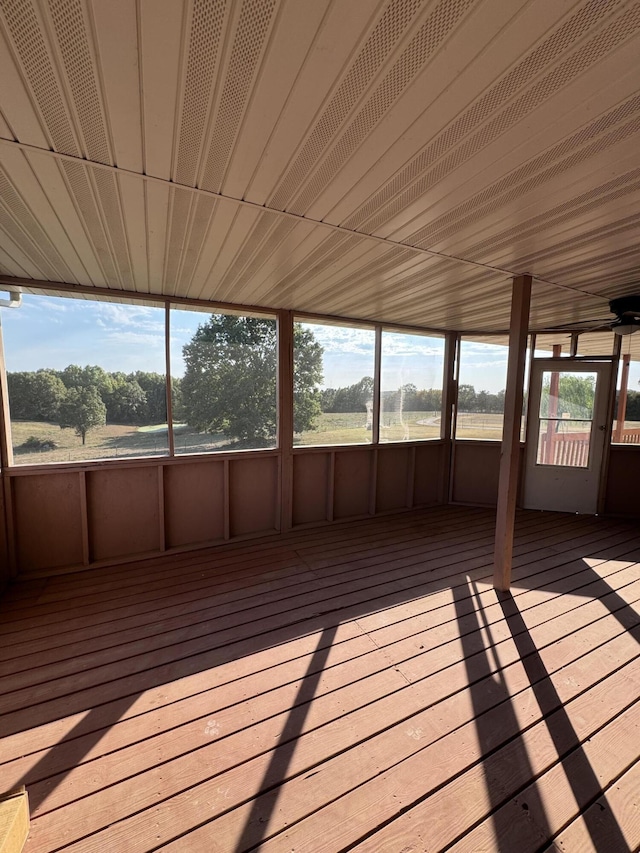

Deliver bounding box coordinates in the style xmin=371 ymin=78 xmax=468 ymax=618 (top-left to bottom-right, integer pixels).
xmin=0 ymin=0 xmax=640 ymax=331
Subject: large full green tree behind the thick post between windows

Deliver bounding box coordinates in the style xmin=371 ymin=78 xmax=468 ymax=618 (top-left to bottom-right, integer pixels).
xmin=180 ymin=314 xmax=322 ymax=443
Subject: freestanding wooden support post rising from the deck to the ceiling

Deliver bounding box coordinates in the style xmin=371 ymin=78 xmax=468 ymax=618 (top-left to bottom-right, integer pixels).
xmin=493 ymin=275 xmax=532 ymax=592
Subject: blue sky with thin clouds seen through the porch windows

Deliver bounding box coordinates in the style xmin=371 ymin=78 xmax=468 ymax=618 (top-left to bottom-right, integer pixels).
xmin=0 ymin=294 xmax=640 ymax=393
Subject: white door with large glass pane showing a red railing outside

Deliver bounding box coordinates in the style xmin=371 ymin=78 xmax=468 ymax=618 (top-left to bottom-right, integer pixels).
xmin=523 ymin=359 xmax=612 ymax=513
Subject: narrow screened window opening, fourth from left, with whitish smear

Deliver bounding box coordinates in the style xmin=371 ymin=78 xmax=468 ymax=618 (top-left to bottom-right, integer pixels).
xmin=380 ymin=331 xmax=444 ymax=442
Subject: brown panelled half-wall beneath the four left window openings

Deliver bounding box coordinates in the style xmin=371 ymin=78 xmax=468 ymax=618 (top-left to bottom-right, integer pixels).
xmin=0 ymin=441 xmax=444 ymax=574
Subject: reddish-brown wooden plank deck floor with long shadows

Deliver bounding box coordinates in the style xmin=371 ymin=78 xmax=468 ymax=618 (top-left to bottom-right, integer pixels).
xmin=0 ymin=507 xmax=640 ymax=853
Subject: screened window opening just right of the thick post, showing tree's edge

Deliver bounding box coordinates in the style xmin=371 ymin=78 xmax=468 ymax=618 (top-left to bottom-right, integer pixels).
xmin=293 ymin=321 xmax=375 ymax=446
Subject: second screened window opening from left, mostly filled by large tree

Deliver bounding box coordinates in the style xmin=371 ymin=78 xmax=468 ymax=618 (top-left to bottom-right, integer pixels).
xmin=169 ymin=307 xmax=278 ymax=454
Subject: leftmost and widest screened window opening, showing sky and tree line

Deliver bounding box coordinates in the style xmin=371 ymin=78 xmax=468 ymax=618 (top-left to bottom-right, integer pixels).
xmin=2 ymin=294 xmax=169 ymax=465
